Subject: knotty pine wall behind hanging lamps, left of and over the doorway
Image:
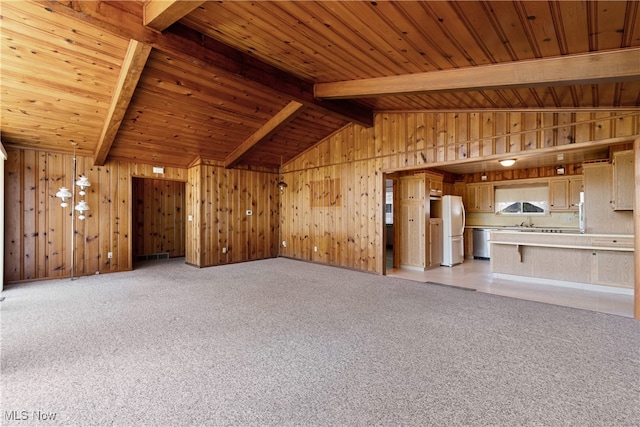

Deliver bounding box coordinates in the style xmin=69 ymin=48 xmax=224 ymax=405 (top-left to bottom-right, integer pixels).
xmin=4 ymin=147 xmax=187 ymax=283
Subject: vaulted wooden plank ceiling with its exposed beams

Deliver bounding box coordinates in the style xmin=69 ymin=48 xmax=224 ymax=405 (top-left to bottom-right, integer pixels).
xmin=0 ymin=0 xmax=640 ymax=169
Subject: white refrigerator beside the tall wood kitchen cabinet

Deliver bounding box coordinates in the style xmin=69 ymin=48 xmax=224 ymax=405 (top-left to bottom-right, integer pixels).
xmin=441 ymin=196 xmax=465 ymax=267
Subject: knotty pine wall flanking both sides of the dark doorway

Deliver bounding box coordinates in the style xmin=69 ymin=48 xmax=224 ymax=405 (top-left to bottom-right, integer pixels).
xmin=4 ymin=147 xmax=279 ymax=283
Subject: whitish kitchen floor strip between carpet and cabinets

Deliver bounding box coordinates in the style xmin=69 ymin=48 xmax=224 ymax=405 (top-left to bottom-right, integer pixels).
xmin=387 ymin=259 xmax=633 ymax=317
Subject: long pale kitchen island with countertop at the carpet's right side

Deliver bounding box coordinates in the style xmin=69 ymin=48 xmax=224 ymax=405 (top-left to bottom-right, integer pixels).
xmin=490 ymin=230 xmax=634 ymax=290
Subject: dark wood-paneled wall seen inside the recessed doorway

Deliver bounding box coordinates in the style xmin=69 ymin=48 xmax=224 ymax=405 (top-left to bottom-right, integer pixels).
xmin=132 ymin=178 xmax=186 ymax=259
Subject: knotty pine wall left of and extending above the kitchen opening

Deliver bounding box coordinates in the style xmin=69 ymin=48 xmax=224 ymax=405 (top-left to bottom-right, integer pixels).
xmin=280 ymin=111 xmax=640 ymax=273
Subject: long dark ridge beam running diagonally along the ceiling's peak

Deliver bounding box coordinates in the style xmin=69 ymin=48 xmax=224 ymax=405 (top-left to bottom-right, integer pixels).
xmin=38 ymin=0 xmax=373 ymax=128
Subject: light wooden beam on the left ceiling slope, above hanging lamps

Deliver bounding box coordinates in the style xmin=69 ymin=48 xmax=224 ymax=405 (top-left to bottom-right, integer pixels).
xmin=93 ymin=40 xmax=151 ymax=166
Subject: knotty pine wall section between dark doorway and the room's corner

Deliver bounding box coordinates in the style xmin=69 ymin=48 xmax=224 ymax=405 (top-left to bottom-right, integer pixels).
xmin=186 ymin=161 xmax=280 ymax=267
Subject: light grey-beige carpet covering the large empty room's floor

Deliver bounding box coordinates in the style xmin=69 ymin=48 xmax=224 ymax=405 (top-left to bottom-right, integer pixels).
xmin=0 ymin=258 xmax=640 ymax=426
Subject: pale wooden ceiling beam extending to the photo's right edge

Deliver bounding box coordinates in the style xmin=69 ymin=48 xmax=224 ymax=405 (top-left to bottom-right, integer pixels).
xmin=314 ymin=48 xmax=640 ymax=99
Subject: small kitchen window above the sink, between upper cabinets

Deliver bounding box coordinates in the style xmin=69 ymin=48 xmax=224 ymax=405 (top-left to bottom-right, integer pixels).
xmin=494 ymin=184 xmax=549 ymax=216
